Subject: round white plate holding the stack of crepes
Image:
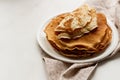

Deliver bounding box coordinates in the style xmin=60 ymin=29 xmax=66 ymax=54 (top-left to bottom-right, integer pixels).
xmin=37 ymin=20 xmax=119 ymax=63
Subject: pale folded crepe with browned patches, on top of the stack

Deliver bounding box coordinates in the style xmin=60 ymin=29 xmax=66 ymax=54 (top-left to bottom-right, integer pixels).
xmin=55 ymin=5 xmax=97 ymax=39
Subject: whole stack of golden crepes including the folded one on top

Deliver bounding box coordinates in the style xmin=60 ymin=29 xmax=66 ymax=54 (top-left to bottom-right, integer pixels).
xmin=45 ymin=5 xmax=112 ymax=58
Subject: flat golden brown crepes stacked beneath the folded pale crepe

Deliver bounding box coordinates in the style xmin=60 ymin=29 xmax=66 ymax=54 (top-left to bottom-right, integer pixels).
xmin=45 ymin=13 xmax=112 ymax=58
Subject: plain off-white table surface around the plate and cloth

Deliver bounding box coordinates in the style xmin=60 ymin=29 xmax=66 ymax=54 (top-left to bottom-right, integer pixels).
xmin=0 ymin=0 xmax=120 ymax=80
